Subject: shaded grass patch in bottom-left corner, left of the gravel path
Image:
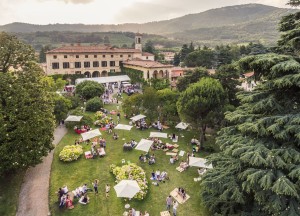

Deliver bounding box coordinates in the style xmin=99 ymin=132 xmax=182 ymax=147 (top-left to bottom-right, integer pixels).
xmin=0 ymin=171 xmax=25 ymax=216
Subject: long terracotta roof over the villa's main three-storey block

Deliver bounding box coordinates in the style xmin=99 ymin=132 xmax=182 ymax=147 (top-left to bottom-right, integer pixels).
xmin=47 ymin=45 xmax=141 ymax=54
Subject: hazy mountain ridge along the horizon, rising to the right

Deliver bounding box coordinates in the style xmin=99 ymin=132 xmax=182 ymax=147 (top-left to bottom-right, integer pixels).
xmin=0 ymin=4 xmax=297 ymax=44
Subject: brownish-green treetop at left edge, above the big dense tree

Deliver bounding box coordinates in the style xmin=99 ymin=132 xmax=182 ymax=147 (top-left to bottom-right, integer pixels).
xmin=0 ymin=32 xmax=35 ymax=73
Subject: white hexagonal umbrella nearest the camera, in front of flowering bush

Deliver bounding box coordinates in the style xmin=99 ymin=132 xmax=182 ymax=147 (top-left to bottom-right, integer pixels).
xmin=114 ymin=180 xmax=141 ymax=199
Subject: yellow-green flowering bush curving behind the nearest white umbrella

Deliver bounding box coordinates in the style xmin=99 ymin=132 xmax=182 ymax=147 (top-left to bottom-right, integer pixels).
xmin=110 ymin=163 xmax=148 ymax=200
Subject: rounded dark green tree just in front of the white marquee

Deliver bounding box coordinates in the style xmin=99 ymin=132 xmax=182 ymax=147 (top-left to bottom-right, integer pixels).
xmin=76 ymin=81 xmax=104 ymax=100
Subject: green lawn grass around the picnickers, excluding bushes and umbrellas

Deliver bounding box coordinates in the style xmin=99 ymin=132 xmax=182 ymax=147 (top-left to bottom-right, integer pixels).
xmin=50 ymin=101 xmax=214 ymax=216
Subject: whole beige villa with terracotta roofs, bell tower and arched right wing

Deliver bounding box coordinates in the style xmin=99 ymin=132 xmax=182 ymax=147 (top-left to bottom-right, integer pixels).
xmin=45 ymin=33 xmax=176 ymax=79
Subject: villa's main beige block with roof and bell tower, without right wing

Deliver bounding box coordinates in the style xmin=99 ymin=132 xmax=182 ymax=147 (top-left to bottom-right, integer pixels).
xmin=44 ymin=33 xmax=154 ymax=77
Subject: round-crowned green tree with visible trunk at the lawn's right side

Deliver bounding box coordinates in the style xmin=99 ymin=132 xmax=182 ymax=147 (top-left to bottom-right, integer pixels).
xmin=177 ymin=77 xmax=226 ymax=148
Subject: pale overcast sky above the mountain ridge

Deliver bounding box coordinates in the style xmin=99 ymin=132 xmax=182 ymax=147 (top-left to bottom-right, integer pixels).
xmin=0 ymin=0 xmax=288 ymax=25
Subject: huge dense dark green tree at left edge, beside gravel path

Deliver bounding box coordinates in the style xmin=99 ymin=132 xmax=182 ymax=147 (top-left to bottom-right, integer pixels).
xmin=0 ymin=62 xmax=55 ymax=175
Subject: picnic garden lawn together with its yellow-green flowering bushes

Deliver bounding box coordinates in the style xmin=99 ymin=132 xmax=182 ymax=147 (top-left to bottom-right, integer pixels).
xmin=50 ymin=100 xmax=214 ymax=216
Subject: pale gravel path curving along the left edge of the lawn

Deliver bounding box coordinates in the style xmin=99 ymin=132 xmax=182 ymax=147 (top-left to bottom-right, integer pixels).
xmin=17 ymin=126 xmax=67 ymax=216
